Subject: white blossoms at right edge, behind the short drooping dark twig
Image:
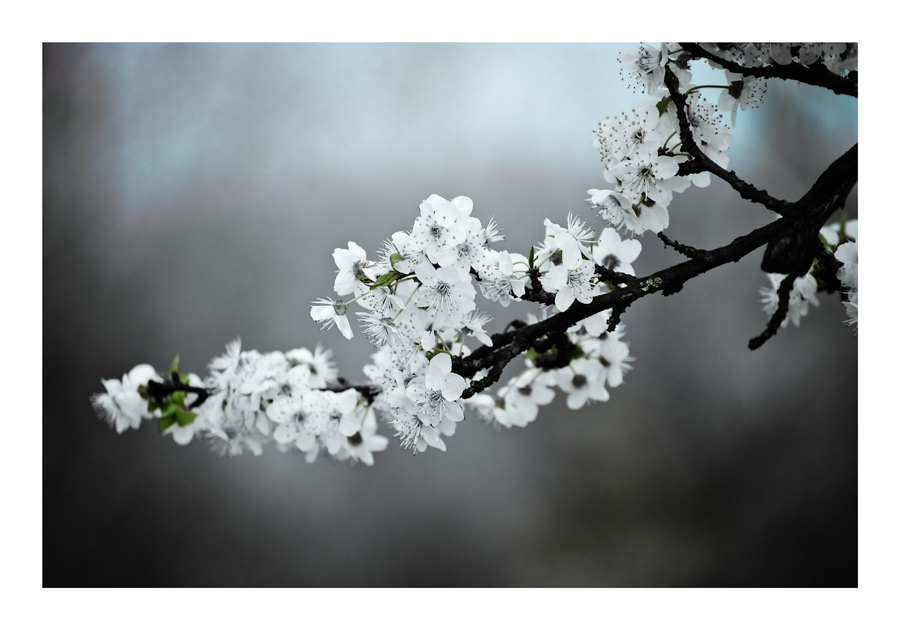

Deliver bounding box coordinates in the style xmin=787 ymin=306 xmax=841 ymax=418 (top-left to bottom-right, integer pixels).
xmin=759 ymin=219 xmax=859 ymax=331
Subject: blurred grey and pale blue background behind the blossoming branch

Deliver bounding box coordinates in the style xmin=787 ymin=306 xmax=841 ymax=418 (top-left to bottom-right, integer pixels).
xmin=43 ymin=44 xmax=857 ymax=586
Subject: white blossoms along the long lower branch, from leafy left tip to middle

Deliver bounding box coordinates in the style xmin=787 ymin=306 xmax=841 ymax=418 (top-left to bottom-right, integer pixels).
xmin=94 ymin=190 xmax=641 ymax=464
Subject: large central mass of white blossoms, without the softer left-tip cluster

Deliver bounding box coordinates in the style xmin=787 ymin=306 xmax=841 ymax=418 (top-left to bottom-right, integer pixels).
xmin=310 ymin=195 xmax=641 ymax=452
